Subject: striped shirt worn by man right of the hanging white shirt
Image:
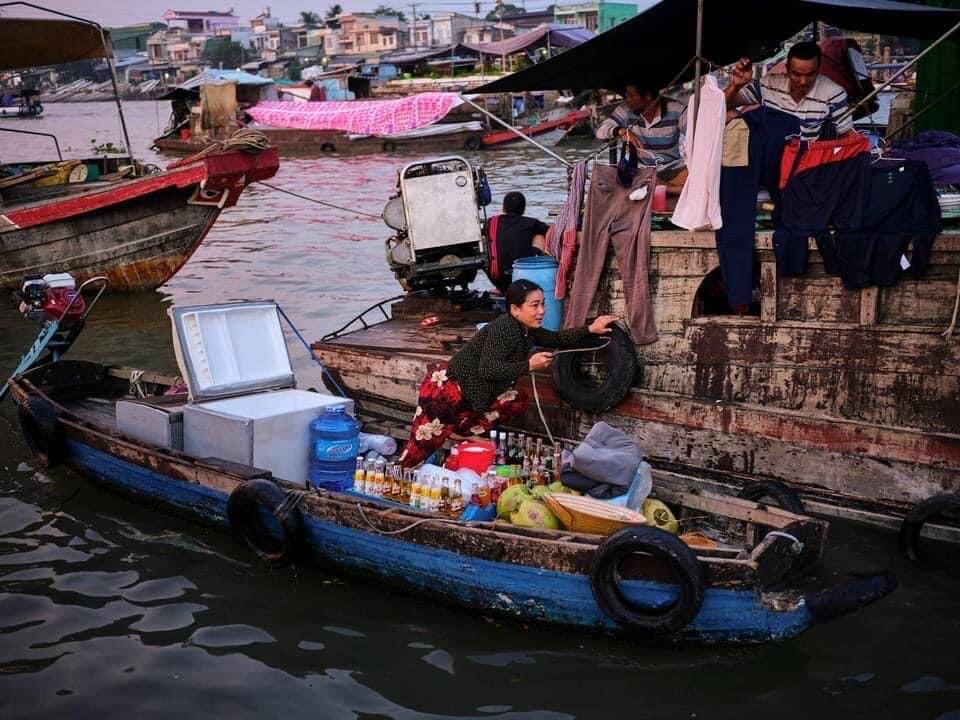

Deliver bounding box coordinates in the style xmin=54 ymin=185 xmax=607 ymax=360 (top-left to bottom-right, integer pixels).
xmin=737 ymin=74 xmax=853 ymax=140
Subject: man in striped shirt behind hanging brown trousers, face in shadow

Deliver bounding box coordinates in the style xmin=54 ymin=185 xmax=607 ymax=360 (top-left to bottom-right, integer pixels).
xmin=596 ymin=82 xmax=687 ymax=194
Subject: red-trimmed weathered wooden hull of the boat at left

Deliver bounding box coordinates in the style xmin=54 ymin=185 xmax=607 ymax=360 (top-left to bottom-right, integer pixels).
xmin=0 ymin=150 xmax=278 ymax=290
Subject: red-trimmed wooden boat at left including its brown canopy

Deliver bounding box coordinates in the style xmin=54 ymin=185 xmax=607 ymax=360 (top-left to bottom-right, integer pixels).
xmin=0 ymin=3 xmax=278 ymax=289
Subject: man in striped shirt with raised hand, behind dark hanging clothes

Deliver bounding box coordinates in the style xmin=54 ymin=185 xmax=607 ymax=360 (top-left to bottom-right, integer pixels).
xmin=724 ymin=42 xmax=853 ymax=140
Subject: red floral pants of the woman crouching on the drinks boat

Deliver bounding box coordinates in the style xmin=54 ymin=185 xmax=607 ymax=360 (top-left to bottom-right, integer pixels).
xmin=400 ymin=362 xmax=528 ymax=467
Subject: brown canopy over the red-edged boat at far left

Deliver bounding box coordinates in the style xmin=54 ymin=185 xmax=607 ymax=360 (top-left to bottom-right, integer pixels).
xmin=0 ymin=18 xmax=113 ymax=70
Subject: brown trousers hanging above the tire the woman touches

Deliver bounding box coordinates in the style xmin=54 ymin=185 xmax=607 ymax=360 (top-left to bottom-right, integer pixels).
xmin=563 ymin=164 xmax=657 ymax=344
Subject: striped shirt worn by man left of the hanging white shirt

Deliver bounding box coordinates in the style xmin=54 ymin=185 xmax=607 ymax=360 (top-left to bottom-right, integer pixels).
xmin=597 ymin=98 xmax=687 ymax=166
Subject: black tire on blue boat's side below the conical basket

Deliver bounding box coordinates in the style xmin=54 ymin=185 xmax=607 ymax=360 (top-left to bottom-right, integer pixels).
xmin=590 ymin=525 xmax=706 ymax=636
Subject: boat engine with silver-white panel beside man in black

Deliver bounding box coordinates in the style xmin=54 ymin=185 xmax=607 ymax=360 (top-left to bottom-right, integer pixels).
xmin=382 ymin=157 xmax=487 ymax=291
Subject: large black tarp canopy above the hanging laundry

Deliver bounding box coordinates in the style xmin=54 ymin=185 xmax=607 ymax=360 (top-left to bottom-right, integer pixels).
xmin=475 ymin=0 xmax=960 ymax=92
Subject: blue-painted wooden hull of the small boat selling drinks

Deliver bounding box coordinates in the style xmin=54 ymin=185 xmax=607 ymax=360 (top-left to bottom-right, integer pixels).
xmin=11 ymin=361 xmax=872 ymax=644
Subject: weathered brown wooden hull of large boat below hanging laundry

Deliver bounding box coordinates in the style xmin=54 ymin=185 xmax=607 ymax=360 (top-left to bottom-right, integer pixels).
xmin=314 ymin=231 xmax=960 ymax=541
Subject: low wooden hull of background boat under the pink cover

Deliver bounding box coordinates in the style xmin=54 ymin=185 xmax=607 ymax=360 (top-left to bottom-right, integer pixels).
xmin=153 ymin=128 xmax=482 ymax=157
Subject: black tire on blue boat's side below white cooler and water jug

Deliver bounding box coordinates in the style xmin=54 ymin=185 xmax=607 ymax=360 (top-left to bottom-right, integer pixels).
xmin=227 ymin=478 xmax=303 ymax=567
